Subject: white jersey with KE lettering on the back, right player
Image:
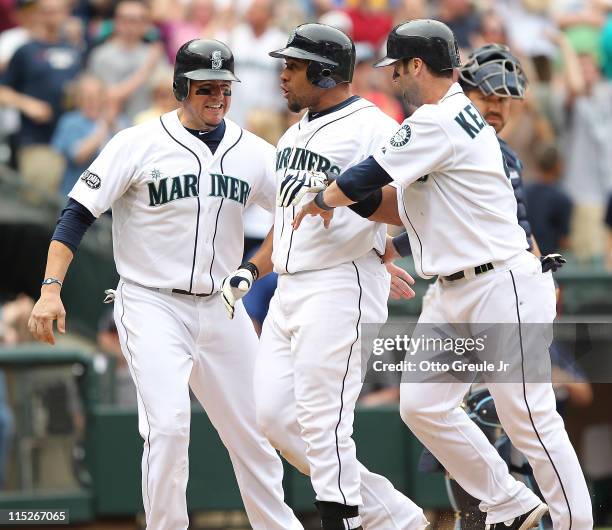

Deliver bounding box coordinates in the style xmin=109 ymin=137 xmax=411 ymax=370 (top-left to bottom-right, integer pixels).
xmin=374 ymin=83 xmax=527 ymax=278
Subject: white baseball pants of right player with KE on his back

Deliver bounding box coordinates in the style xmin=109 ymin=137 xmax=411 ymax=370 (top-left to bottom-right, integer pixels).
xmin=400 ymin=252 xmax=593 ymax=530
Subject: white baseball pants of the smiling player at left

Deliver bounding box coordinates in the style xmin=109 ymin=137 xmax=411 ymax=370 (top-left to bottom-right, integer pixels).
xmin=115 ymin=280 xmax=303 ymax=530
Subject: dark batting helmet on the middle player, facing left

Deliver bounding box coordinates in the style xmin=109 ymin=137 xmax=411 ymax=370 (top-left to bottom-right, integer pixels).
xmin=270 ymin=24 xmax=355 ymax=88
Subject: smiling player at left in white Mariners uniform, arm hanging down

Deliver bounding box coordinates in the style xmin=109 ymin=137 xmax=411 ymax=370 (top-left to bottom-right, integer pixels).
xmin=29 ymin=40 xmax=303 ymax=530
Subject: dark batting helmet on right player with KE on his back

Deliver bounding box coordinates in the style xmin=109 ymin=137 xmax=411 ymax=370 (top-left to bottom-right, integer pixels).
xmin=374 ymin=19 xmax=461 ymax=72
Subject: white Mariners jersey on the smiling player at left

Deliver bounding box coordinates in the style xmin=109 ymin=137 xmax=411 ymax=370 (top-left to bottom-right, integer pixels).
xmin=69 ymin=111 xmax=275 ymax=293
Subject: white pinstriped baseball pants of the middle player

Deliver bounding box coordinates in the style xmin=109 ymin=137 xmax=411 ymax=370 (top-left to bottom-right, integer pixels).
xmin=255 ymin=253 xmax=427 ymax=530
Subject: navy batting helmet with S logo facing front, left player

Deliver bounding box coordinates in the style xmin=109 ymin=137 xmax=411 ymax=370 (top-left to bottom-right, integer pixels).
xmin=172 ymin=39 xmax=240 ymax=101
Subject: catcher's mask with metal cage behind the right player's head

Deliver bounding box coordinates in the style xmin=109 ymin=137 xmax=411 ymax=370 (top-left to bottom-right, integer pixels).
xmin=459 ymin=44 xmax=527 ymax=99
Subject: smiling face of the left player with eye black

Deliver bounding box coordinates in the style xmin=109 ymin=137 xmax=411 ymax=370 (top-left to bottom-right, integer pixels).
xmin=183 ymin=80 xmax=232 ymax=130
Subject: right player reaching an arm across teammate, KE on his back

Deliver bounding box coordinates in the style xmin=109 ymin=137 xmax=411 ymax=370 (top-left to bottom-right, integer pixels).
xmin=286 ymin=20 xmax=593 ymax=530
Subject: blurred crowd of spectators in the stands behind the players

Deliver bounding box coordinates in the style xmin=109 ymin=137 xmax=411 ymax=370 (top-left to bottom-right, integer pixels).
xmin=0 ymin=0 xmax=612 ymax=264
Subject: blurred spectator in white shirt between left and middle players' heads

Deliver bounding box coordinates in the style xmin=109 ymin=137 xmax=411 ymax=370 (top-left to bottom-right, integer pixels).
xmin=219 ymin=0 xmax=287 ymax=127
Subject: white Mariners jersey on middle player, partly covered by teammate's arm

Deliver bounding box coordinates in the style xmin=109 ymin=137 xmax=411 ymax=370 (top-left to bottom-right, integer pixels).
xmin=272 ymin=98 xmax=398 ymax=274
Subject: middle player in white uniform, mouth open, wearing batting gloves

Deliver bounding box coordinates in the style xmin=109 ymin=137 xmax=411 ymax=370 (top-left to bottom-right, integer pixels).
xmin=224 ymin=24 xmax=427 ymax=530
